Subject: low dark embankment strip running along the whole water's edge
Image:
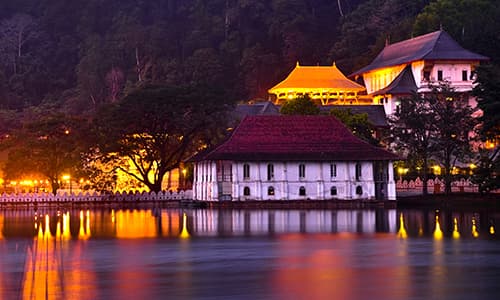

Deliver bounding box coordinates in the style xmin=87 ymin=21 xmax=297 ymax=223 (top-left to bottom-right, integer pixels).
xmin=0 ymin=193 xmax=500 ymax=210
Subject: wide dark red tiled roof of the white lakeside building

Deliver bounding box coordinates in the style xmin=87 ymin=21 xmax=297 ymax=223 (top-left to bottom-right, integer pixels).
xmin=193 ymin=116 xmax=398 ymax=161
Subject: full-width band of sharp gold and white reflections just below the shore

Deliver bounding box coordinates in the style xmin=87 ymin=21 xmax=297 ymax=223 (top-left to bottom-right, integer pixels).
xmin=0 ymin=209 xmax=500 ymax=240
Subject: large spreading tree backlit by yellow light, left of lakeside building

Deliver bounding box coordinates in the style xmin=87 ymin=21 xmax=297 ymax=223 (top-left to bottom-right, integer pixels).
xmin=94 ymin=86 xmax=232 ymax=191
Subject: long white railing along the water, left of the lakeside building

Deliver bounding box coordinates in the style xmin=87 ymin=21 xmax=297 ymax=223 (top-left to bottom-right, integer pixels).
xmin=0 ymin=190 xmax=193 ymax=204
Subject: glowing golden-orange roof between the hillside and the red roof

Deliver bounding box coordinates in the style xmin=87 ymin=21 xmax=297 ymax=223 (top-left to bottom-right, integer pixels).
xmin=269 ymin=62 xmax=365 ymax=94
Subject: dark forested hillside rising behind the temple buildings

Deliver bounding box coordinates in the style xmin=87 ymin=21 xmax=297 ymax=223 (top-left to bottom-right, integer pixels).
xmin=0 ymin=0 xmax=500 ymax=120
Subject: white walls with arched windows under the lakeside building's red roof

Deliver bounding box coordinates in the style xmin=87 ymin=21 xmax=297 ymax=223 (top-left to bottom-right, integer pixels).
xmin=193 ymin=162 xmax=396 ymax=201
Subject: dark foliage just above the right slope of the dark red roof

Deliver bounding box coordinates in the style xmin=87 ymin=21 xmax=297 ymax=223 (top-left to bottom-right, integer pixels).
xmin=330 ymin=108 xmax=379 ymax=145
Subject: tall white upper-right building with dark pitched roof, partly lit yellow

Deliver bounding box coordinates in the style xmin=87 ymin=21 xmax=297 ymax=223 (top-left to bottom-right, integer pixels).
xmin=350 ymin=30 xmax=488 ymax=114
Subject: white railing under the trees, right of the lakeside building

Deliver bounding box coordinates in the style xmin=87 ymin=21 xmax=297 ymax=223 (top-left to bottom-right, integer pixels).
xmin=396 ymin=177 xmax=478 ymax=193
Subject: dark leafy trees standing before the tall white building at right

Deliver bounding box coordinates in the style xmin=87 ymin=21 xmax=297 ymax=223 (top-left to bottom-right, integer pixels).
xmin=389 ymin=83 xmax=477 ymax=193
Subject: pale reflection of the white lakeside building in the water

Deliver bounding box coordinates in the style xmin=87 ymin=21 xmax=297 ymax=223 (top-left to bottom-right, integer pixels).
xmin=192 ymin=210 xmax=396 ymax=236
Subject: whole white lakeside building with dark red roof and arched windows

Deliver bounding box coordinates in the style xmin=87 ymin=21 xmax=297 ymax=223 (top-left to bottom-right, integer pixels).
xmin=193 ymin=116 xmax=397 ymax=201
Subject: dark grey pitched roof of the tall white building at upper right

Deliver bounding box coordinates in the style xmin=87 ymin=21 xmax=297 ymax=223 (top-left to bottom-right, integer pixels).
xmin=350 ymin=30 xmax=489 ymax=76
